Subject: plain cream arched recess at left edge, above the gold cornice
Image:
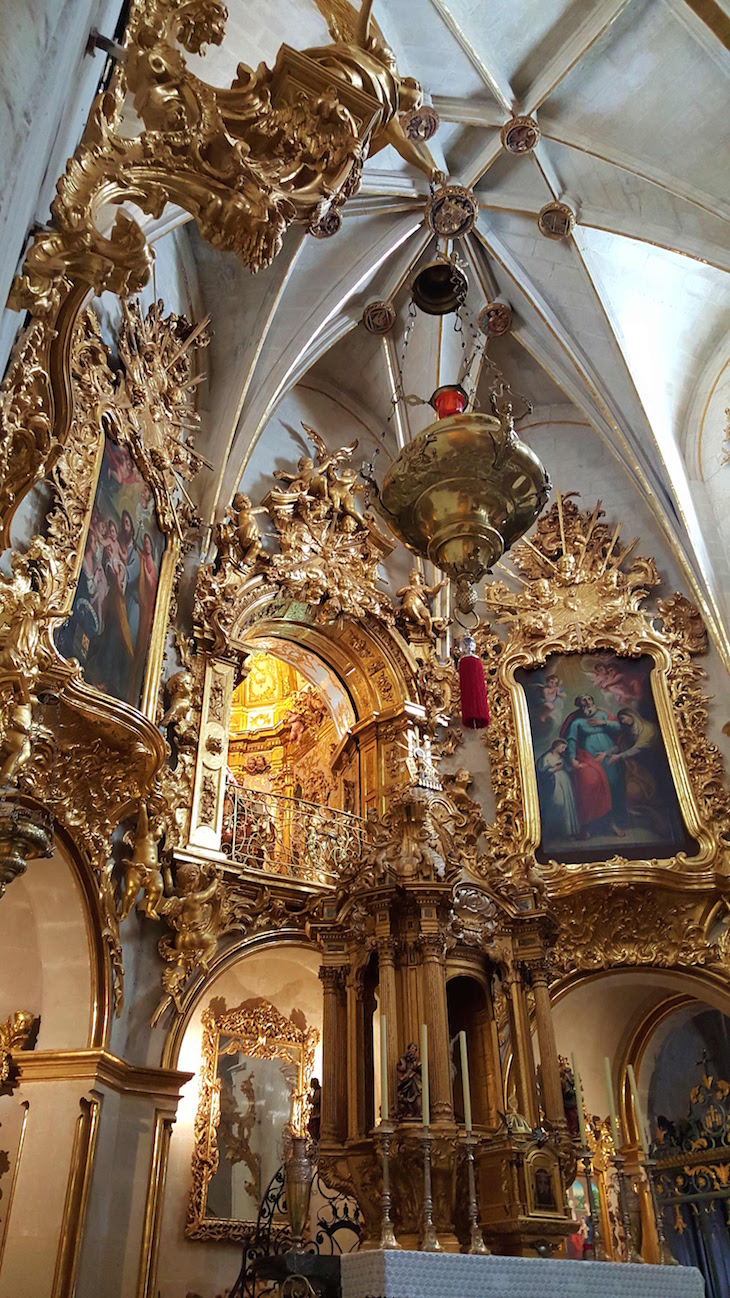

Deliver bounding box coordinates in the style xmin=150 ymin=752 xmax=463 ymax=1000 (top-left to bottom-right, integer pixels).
xmin=0 ymin=841 xmax=102 ymax=1050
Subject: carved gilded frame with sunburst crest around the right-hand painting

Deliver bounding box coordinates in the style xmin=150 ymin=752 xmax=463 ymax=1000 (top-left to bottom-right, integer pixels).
xmin=467 ymin=496 xmax=730 ymax=897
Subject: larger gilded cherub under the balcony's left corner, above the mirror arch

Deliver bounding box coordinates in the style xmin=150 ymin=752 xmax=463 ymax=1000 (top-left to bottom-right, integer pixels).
xmin=159 ymin=862 xmax=223 ymax=1022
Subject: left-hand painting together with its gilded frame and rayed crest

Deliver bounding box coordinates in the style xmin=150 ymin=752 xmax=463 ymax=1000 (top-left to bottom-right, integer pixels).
xmin=48 ymin=302 xmax=208 ymax=720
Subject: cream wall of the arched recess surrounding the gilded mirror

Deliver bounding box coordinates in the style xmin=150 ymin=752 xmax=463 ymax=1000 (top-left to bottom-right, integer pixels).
xmin=158 ymin=937 xmax=322 ymax=1293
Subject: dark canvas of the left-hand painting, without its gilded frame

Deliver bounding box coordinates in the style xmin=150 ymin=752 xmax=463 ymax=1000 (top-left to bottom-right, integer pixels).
xmin=56 ymin=437 xmax=165 ymax=707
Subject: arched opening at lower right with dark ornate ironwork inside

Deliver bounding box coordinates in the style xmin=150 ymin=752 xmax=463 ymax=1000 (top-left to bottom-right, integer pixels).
xmin=553 ymin=968 xmax=730 ymax=1272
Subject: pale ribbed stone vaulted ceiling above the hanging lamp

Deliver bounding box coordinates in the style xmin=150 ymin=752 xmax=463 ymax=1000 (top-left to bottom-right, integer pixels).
xmin=150 ymin=0 xmax=730 ymax=661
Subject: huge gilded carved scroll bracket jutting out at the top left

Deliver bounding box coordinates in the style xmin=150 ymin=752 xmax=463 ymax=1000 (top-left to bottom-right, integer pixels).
xmin=0 ymin=0 xmax=430 ymax=524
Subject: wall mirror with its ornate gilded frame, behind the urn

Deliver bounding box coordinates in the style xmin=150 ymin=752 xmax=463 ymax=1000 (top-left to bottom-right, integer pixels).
xmin=186 ymin=1001 xmax=320 ymax=1242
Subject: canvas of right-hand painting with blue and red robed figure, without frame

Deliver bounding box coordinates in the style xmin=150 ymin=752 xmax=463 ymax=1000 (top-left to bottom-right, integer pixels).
xmin=516 ymin=653 xmax=692 ymax=864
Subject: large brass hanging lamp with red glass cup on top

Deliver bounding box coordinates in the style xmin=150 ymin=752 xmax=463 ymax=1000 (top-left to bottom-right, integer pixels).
xmin=379 ymin=384 xmax=549 ymax=602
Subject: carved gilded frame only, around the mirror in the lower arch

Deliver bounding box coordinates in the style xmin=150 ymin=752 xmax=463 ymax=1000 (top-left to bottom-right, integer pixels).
xmin=184 ymin=999 xmax=320 ymax=1243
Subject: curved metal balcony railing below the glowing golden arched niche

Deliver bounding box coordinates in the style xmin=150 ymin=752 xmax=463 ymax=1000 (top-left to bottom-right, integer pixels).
xmin=216 ymin=785 xmax=366 ymax=884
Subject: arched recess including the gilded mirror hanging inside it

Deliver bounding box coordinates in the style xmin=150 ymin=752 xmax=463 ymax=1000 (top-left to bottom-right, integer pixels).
xmin=158 ymin=940 xmax=322 ymax=1293
